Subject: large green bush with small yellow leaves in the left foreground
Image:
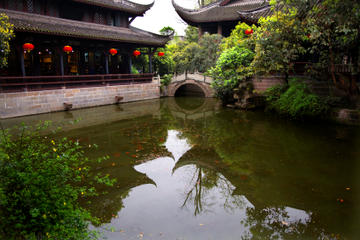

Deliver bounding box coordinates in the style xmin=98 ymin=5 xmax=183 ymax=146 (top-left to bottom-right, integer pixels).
xmin=0 ymin=123 xmax=114 ymax=240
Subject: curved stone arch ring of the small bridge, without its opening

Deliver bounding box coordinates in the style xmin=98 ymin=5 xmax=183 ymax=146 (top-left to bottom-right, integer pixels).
xmin=168 ymin=79 xmax=214 ymax=97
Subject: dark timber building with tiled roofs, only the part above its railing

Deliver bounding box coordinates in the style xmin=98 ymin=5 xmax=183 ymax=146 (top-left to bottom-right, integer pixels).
xmin=0 ymin=0 xmax=170 ymax=76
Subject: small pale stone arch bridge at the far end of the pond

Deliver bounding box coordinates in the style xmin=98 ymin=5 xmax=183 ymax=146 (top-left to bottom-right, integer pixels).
xmin=167 ymin=73 xmax=214 ymax=97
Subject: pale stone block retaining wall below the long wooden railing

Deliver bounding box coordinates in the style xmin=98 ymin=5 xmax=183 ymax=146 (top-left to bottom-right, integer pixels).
xmin=0 ymin=81 xmax=160 ymax=119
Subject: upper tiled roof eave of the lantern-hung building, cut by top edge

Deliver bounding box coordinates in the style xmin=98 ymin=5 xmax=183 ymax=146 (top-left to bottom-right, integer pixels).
xmin=73 ymin=0 xmax=154 ymax=15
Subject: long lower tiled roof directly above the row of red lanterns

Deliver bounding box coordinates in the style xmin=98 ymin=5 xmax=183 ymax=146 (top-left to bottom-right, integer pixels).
xmin=0 ymin=9 xmax=170 ymax=46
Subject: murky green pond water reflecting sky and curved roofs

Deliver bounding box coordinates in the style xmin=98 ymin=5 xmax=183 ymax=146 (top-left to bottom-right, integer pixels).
xmin=3 ymin=98 xmax=360 ymax=240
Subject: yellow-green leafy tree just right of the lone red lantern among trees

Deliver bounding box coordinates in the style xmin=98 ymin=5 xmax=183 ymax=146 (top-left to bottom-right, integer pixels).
xmin=253 ymin=8 xmax=306 ymax=74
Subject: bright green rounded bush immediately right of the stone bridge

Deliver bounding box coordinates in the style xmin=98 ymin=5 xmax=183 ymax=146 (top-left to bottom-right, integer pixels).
xmin=209 ymin=47 xmax=254 ymax=102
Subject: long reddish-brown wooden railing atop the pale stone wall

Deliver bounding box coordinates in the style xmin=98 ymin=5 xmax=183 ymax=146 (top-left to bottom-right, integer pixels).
xmin=0 ymin=73 xmax=154 ymax=92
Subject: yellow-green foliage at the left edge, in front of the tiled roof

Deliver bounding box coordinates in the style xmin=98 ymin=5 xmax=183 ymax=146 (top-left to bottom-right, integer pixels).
xmin=0 ymin=13 xmax=15 ymax=68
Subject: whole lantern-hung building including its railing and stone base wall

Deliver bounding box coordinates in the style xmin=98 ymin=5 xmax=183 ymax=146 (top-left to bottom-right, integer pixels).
xmin=0 ymin=0 xmax=170 ymax=119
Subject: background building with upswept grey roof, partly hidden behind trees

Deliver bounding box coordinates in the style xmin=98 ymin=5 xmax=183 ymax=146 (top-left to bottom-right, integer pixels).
xmin=172 ymin=0 xmax=271 ymax=37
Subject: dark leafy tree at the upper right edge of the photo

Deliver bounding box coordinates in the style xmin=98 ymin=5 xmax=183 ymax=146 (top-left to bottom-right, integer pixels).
xmin=306 ymin=0 xmax=360 ymax=98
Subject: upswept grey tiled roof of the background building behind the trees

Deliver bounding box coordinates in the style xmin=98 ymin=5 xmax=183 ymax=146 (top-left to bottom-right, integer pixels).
xmin=172 ymin=0 xmax=269 ymax=24
